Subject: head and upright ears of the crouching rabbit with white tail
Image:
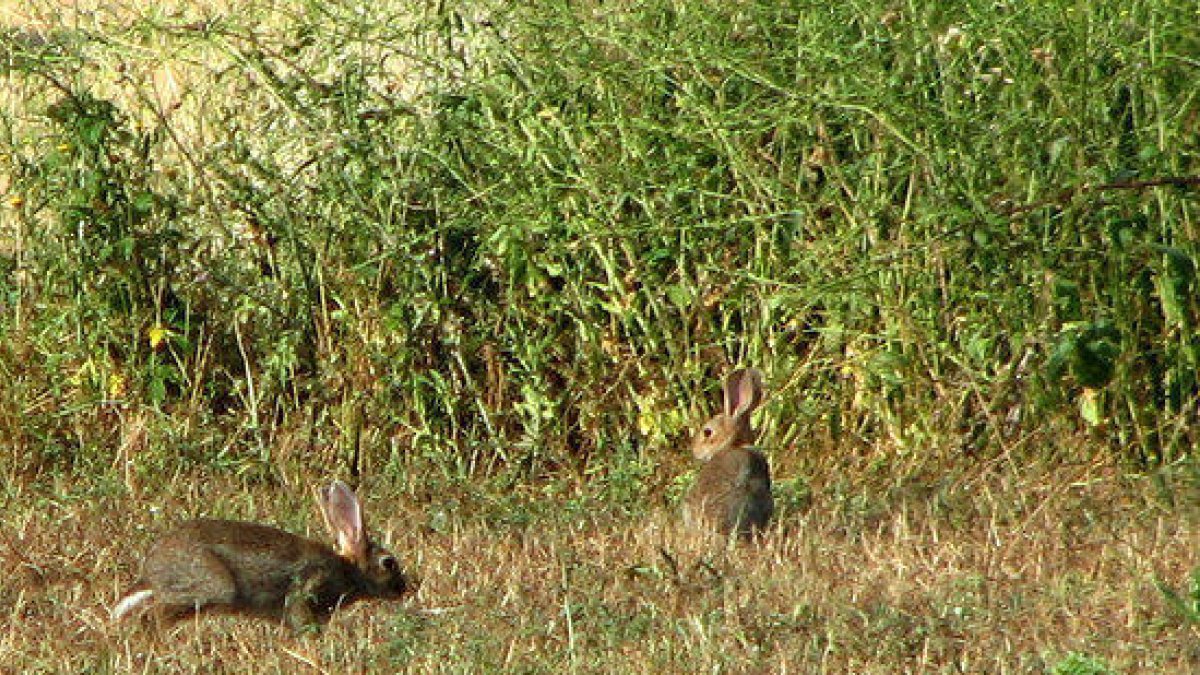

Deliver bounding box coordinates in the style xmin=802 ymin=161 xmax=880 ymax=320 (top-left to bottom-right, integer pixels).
xmin=318 ymin=480 xmax=408 ymax=598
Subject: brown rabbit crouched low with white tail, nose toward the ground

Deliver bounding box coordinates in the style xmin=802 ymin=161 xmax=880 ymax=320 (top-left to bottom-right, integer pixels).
xmin=113 ymin=480 xmax=408 ymax=631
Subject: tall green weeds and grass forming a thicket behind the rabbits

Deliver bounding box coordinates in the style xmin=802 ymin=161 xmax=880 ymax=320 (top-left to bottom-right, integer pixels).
xmin=0 ymin=1 xmax=1200 ymax=476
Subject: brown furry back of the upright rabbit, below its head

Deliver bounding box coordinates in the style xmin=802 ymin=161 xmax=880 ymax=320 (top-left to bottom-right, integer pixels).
xmin=688 ymin=447 xmax=774 ymax=536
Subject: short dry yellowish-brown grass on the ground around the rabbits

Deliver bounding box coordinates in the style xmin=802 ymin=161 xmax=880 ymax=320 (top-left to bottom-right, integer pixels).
xmin=0 ymin=446 xmax=1200 ymax=673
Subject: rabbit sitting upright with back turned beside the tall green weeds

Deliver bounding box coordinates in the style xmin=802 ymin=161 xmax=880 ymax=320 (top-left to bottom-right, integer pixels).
xmin=684 ymin=369 xmax=775 ymax=537
